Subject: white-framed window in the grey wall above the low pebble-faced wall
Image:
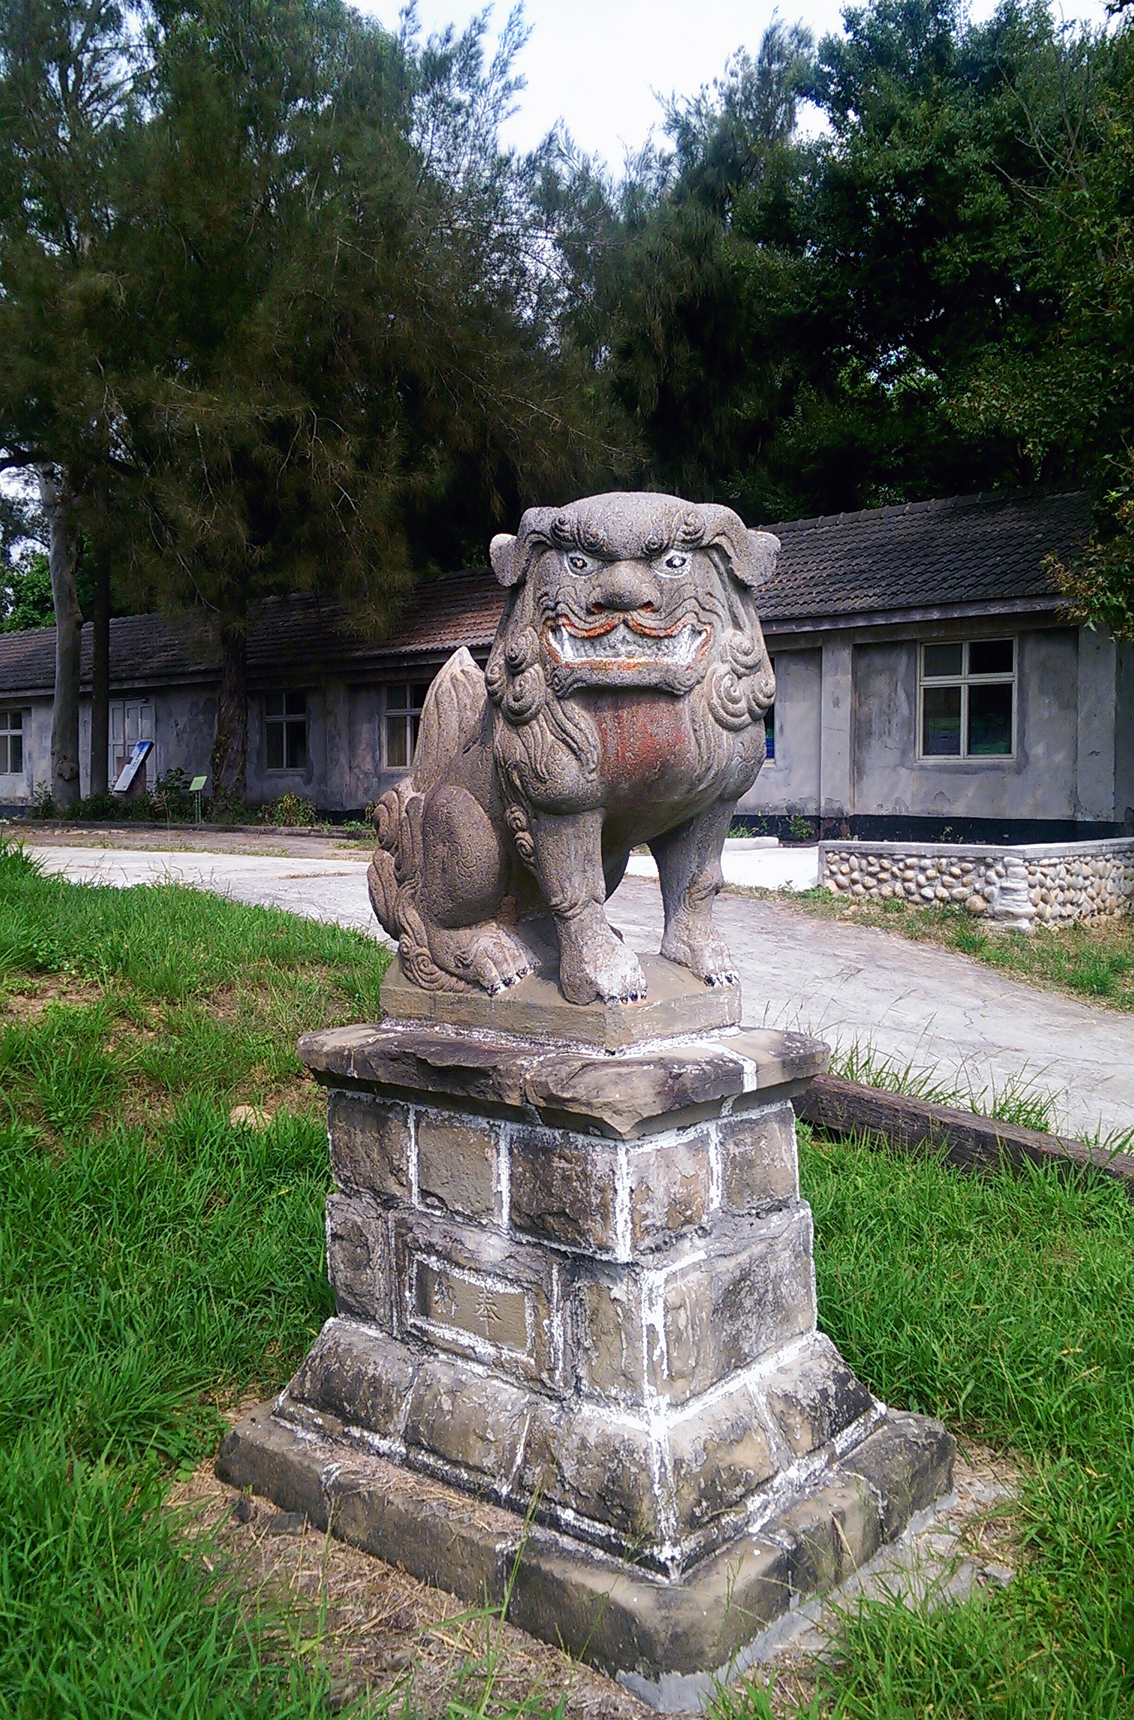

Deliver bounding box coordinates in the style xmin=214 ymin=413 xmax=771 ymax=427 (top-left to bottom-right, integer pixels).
xmin=919 ymin=640 xmax=1015 ymax=759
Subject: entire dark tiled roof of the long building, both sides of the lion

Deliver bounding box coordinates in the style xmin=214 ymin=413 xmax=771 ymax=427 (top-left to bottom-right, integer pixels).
xmin=0 ymin=490 xmax=1089 ymax=695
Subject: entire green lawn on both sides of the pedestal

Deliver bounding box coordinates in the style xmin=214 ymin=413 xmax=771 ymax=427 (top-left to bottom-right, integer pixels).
xmin=0 ymin=850 xmax=1134 ymax=1720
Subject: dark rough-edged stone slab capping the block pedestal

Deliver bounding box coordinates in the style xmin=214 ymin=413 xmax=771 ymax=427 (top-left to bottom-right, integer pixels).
xmin=299 ymin=1022 xmax=829 ymax=1139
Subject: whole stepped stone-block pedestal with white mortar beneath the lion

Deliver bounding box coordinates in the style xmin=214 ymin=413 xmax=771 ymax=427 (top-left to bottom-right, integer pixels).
xmin=219 ymin=963 xmax=952 ymax=1710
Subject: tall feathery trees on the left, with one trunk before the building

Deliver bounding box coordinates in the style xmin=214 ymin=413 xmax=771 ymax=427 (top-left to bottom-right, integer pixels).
xmin=0 ymin=0 xmax=609 ymax=800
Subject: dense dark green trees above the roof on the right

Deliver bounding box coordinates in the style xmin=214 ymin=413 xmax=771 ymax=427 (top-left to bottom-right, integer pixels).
xmin=539 ymin=0 xmax=1134 ymax=519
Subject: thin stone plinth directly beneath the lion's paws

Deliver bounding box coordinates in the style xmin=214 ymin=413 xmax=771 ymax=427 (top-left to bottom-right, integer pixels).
xmin=382 ymin=956 xmax=742 ymax=1051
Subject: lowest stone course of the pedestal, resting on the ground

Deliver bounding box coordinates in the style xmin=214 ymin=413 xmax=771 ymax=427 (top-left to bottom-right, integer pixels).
xmin=217 ymin=1405 xmax=953 ymax=1713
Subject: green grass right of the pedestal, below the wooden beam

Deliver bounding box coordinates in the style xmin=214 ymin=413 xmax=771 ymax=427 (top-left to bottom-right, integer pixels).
xmin=802 ymin=1142 xmax=1134 ymax=1720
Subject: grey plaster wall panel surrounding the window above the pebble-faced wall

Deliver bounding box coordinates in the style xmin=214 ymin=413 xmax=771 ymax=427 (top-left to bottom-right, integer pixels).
xmin=856 ymin=628 xmax=1080 ymax=819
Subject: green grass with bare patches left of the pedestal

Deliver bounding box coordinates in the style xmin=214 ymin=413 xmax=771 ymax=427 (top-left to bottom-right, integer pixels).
xmin=0 ymin=851 xmax=384 ymax=1720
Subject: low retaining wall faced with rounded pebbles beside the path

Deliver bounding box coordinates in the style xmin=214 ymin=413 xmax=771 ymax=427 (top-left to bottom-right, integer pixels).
xmin=819 ymin=836 xmax=1134 ymax=931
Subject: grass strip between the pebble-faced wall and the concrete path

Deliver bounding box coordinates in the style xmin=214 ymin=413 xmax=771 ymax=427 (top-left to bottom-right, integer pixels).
xmin=746 ymin=886 xmax=1134 ymax=1010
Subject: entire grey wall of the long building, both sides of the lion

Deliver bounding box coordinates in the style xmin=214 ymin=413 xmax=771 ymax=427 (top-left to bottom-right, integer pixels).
xmin=0 ymin=626 xmax=1134 ymax=827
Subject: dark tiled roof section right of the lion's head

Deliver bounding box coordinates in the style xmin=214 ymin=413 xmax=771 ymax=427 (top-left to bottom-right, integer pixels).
xmin=757 ymin=490 xmax=1089 ymax=623
